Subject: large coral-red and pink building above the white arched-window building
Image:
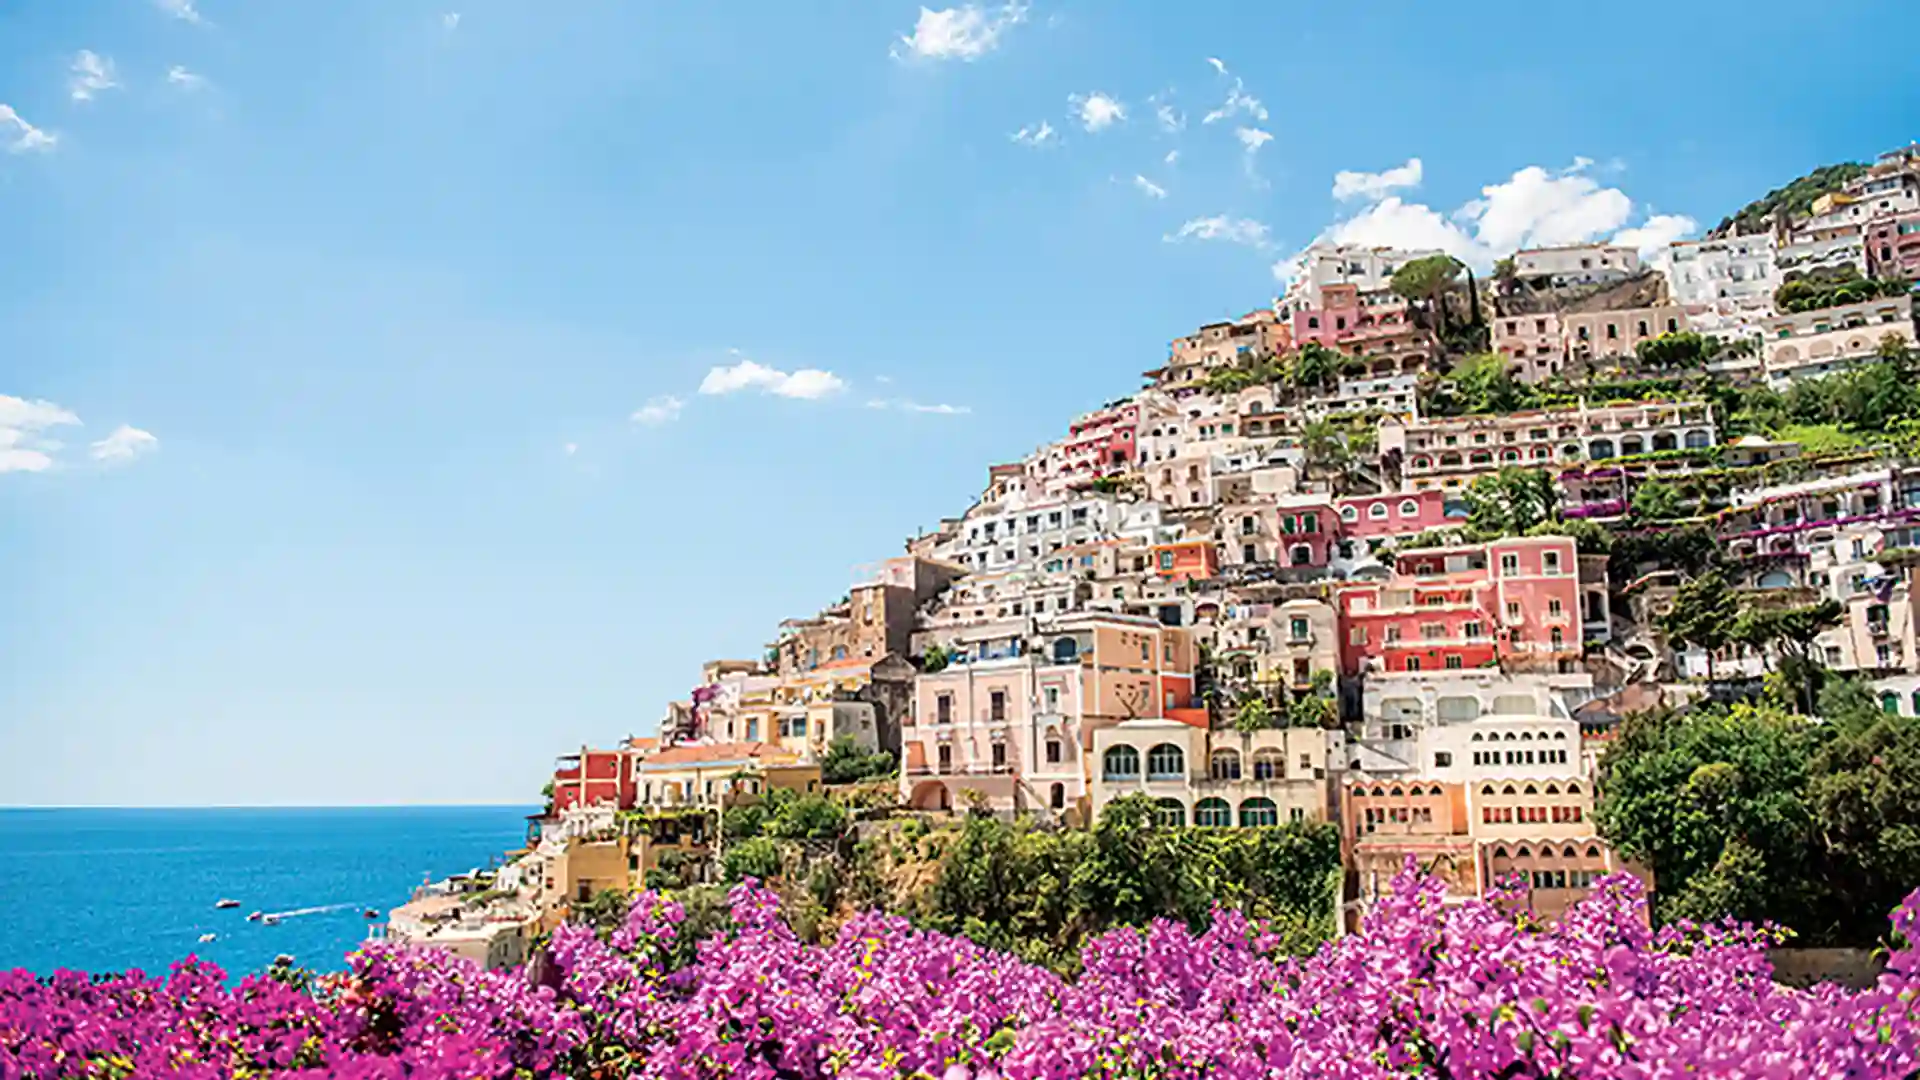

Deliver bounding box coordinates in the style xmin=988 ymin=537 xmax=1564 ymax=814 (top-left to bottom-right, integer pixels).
xmin=1340 ymin=536 xmax=1584 ymax=675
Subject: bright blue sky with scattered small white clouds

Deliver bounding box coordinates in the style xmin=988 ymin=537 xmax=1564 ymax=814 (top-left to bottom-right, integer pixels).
xmin=0 ymin=0 xmax=1920 ymax=803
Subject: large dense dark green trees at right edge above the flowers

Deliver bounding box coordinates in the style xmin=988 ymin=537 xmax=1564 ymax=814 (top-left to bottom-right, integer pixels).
xmin=1597 ymin=676 xmax=1920 ymax=945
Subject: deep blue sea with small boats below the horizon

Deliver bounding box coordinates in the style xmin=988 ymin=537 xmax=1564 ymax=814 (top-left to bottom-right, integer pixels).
xmin=0 ymin=807 xmax=538 ymax=976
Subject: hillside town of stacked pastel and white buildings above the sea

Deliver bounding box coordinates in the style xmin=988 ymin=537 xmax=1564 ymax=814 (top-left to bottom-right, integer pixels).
xmin=386 ymin=146 xmax=1920 ymax=967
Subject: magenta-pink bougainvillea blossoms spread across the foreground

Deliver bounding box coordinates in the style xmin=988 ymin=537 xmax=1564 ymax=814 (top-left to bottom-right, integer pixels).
xmin=0 ymin=872 xmax=1920 ymax=1080
